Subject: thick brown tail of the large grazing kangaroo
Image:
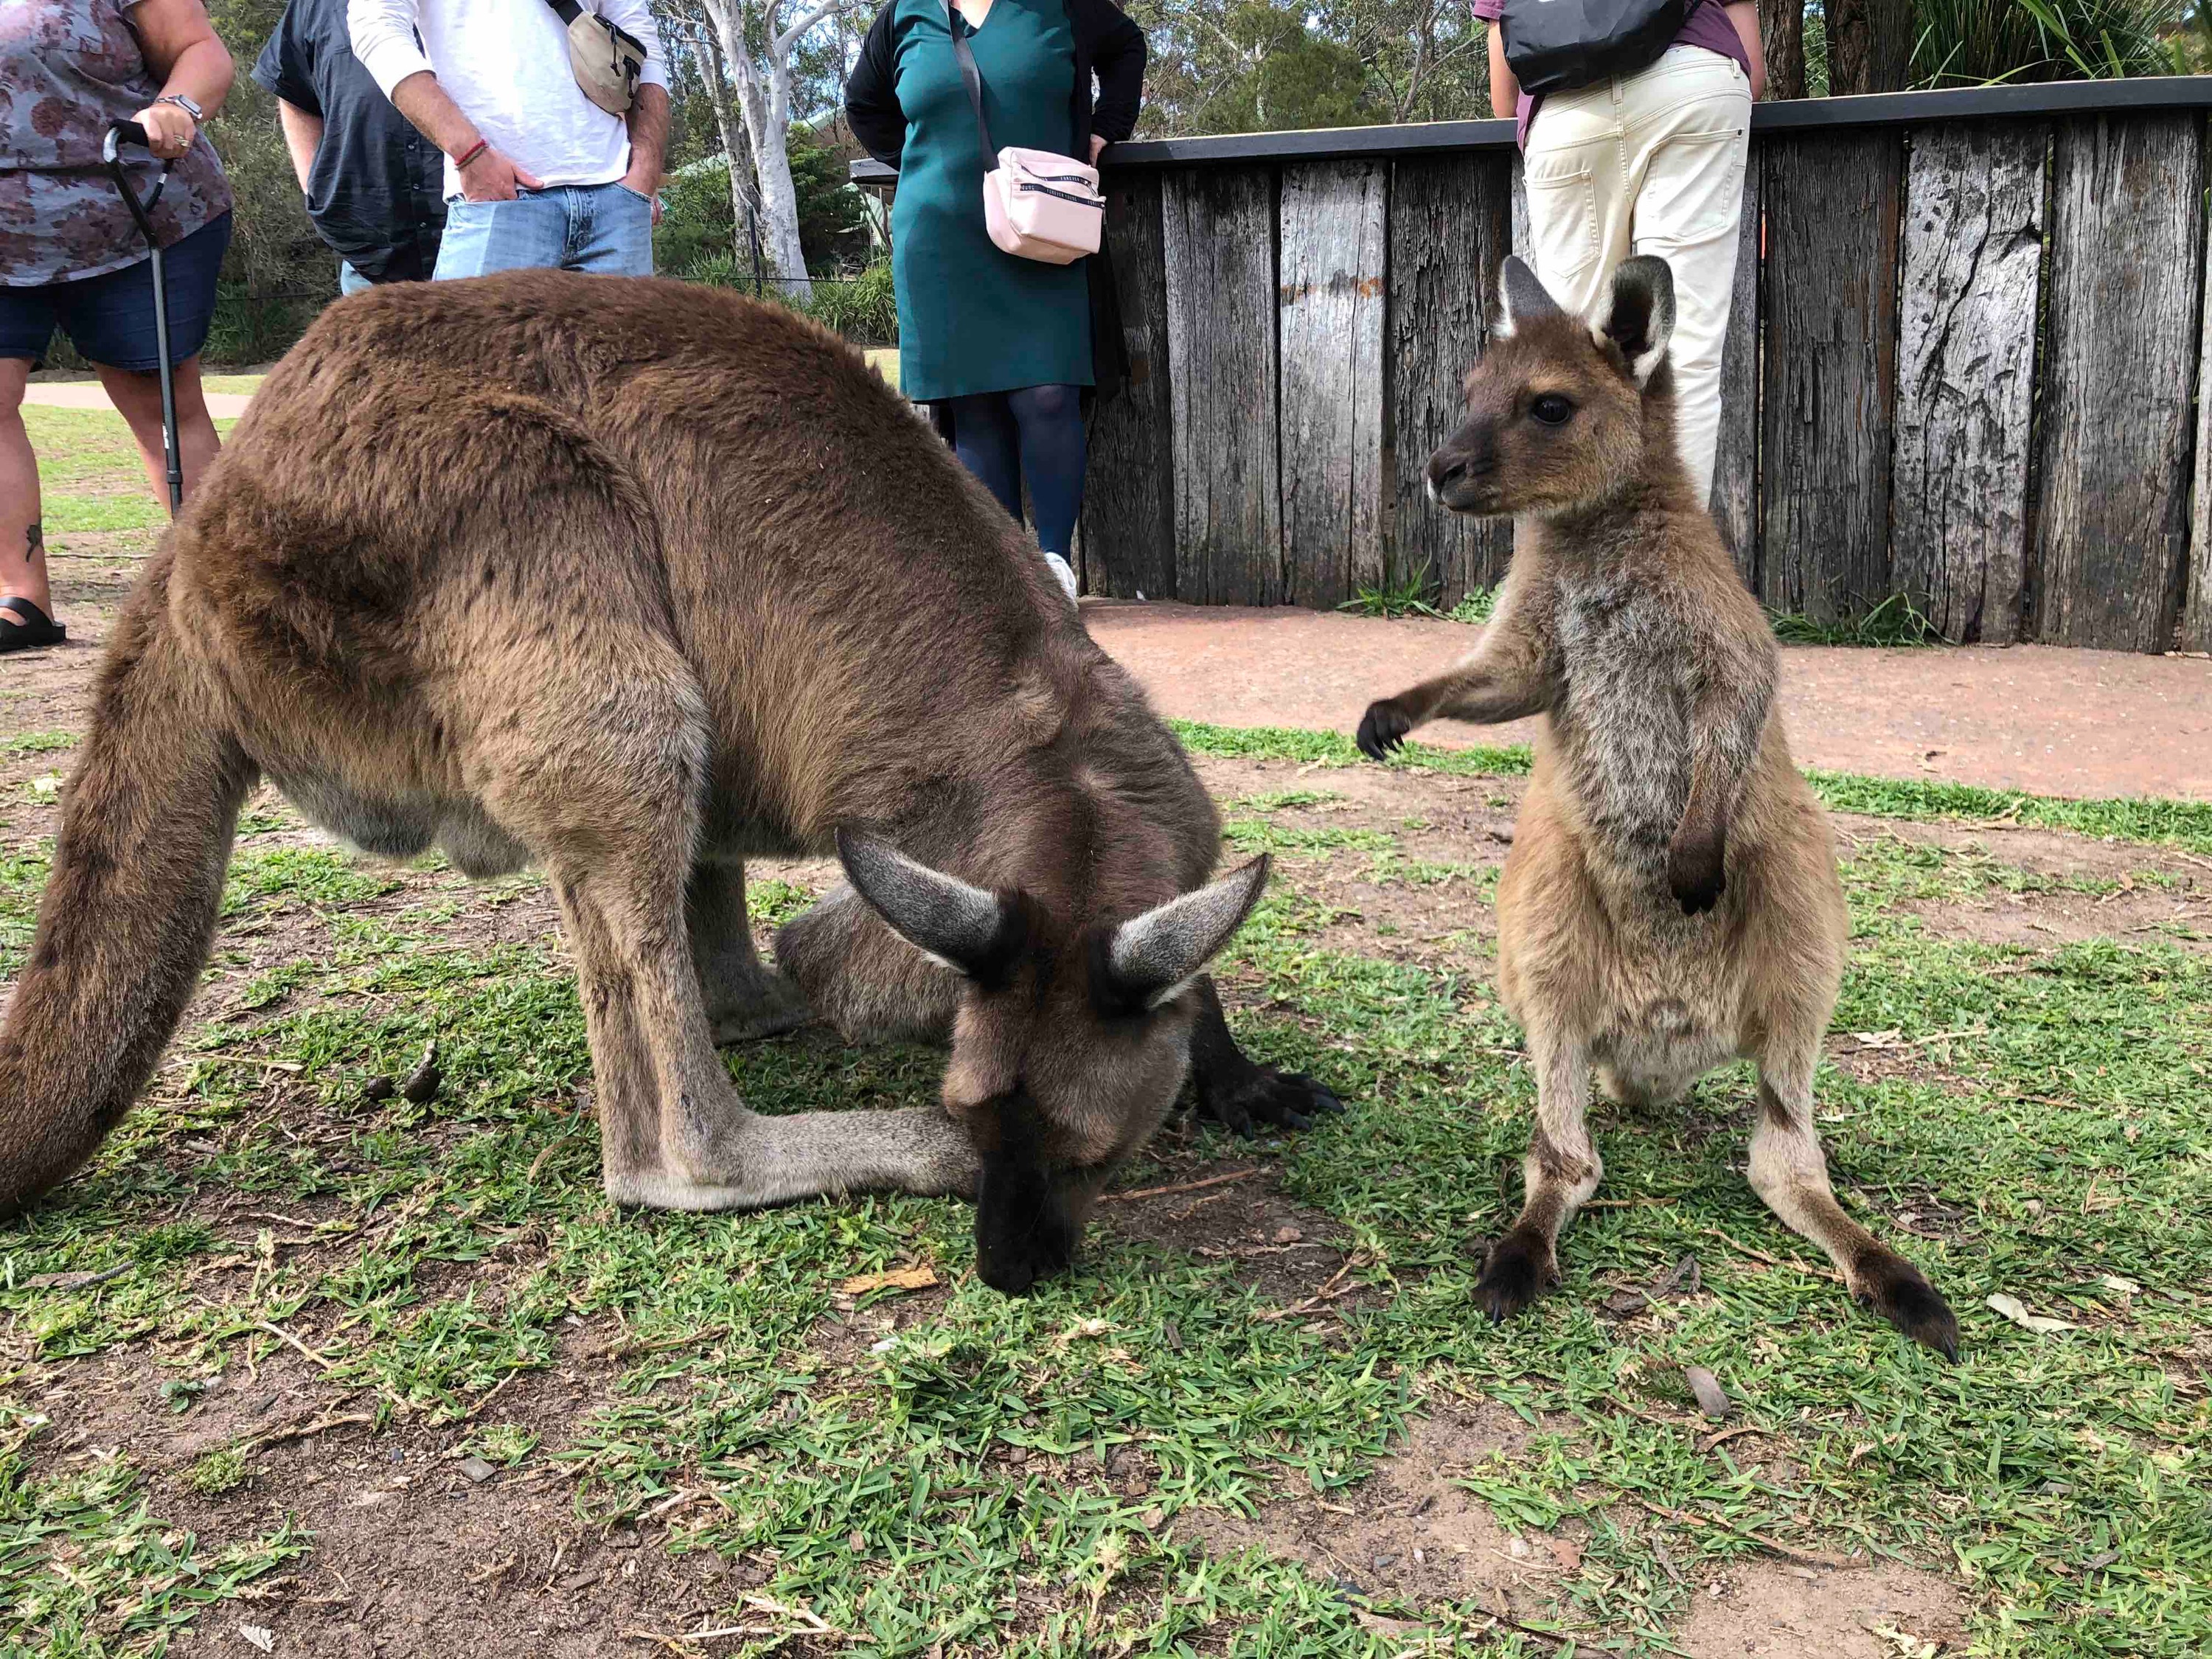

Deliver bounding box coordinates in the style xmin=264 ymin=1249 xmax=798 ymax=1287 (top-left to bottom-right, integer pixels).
xmin=0 ymin=580 xmax=257 ymax=1214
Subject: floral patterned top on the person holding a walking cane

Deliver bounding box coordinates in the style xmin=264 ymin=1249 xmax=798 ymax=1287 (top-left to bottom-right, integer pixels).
xmin=0 ymin=0 xmax=230 ymax=288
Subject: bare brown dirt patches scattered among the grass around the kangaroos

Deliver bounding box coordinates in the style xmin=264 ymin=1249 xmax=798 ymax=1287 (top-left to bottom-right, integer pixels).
xmin=0 ymin=553 xmax=2212 ymax=1659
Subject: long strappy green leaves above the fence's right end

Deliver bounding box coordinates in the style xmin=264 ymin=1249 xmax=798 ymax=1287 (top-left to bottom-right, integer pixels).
xmin=1913 ymin=0 xmax=2212 ymax=86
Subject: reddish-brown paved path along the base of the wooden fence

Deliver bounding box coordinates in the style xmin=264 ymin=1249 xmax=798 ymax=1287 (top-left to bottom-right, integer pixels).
xmin=1084 ymin=599 xmax=2212 ymax=801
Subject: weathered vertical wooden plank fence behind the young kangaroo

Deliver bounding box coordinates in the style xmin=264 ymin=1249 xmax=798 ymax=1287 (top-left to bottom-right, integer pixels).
xmin=856 ymin=77 xmax=2212 ymax=650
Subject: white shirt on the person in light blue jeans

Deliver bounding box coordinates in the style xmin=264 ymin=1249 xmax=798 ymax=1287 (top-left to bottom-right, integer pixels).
xmin=345 ymin=0 xmax=668 ymax=197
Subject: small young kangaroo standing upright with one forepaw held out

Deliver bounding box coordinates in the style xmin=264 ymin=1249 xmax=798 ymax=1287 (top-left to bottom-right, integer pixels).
xmin=1358 ymin=257 xmax=1958 ymax=1358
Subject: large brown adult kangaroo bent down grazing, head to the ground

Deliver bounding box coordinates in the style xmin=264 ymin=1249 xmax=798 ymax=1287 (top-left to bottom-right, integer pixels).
xmin=0 ymin=272 xmax=1336 ymax=1292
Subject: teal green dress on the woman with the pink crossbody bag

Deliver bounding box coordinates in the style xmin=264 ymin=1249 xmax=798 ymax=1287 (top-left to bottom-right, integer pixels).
xmin=891 ymin=0 xmax=1093 ymax=403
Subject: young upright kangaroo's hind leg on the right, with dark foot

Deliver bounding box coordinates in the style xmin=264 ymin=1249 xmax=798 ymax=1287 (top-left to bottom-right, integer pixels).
xmin=1752 ymin=1035 xmax=1958 ymax=1360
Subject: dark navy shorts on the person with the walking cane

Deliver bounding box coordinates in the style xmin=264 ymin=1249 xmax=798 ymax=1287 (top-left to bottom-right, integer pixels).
xmin=0 ymin=212 xmax=230 ymax=374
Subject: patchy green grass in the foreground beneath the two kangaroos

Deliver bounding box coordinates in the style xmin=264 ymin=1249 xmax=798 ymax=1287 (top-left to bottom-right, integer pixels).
xmin=0 ymin=726 xmax=2212 ymax=1659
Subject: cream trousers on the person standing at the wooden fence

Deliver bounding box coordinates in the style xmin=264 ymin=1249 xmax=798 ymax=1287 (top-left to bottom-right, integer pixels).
xmin=1526 ymin=46 xmax=1752 ymax=500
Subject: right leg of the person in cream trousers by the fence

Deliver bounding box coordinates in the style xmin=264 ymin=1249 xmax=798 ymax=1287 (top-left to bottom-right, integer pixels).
xmin=1628 ymin=49 xmax=1752 ymax=500
